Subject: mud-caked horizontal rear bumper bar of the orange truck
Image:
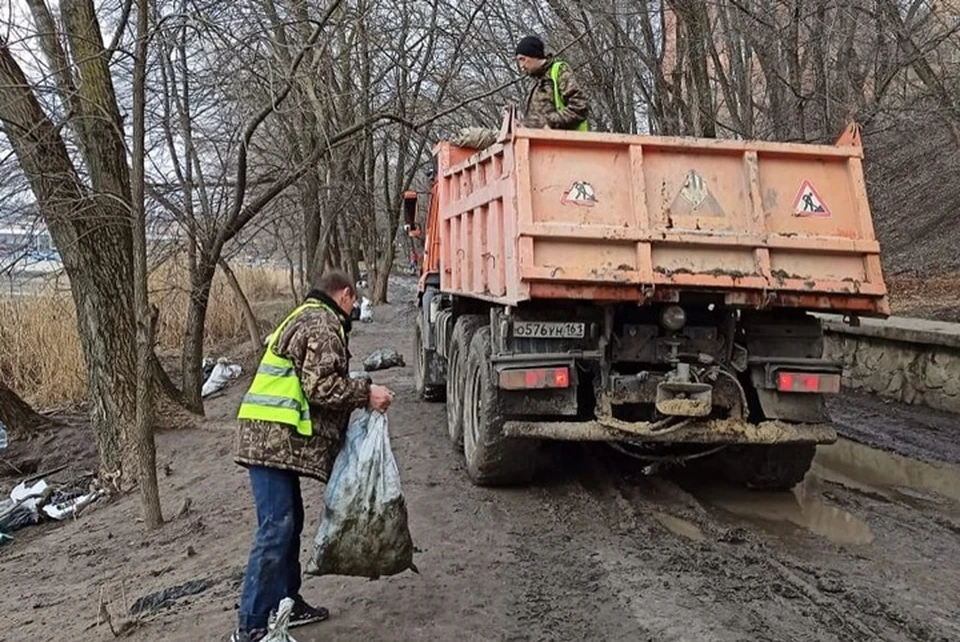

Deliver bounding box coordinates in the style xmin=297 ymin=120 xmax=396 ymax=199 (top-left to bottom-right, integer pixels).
xmin=503 ymin=419 xmax=837 ymax=444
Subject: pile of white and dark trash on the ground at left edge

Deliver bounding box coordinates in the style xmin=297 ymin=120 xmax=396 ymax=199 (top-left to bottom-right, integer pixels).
xmin=0 ymin=479 xmax=106 ymax=543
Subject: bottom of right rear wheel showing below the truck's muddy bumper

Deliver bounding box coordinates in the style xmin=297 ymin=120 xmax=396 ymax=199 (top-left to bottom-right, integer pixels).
xmin=720 ymin=444 xmax=817 ymax=490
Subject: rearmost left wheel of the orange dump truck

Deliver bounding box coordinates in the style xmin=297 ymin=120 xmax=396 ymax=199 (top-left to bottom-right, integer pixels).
xmin=462 ymin=328 xmax=537 ymax=486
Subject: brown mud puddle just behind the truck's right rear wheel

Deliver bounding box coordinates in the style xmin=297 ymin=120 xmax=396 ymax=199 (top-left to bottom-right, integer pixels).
xmin=692 ymin=477 xmax=873 ymax=545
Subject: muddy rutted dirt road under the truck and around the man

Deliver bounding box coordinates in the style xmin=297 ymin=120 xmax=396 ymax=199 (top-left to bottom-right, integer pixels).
xmin=0 ymin=292 xmax=960 ymax=642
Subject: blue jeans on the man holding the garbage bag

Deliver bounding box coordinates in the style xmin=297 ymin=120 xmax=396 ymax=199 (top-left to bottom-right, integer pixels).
xmin=240 ymin=466 xmax=303 ymax=631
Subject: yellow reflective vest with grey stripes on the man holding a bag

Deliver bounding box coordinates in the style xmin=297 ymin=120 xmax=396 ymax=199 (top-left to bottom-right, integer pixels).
xmin=237 ymin=300 xmax=346 ymax=437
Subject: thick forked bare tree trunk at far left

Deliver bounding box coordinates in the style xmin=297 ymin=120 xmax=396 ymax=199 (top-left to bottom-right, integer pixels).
xmin=0 ymin=0 xmax=137 ymax=479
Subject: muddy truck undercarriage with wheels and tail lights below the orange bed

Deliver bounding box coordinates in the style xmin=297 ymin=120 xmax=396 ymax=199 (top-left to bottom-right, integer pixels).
xmin=415 ymin=278 xmax=841 ymax=489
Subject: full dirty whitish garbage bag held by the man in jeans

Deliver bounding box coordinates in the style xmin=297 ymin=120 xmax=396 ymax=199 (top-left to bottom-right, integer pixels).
xmin=306 ymin=410 xmax=419 ymax=579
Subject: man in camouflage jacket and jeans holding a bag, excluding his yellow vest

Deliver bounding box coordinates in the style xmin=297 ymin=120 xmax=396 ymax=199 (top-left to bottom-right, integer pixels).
xmin=231 ymin=272 xmax=393 ymax=642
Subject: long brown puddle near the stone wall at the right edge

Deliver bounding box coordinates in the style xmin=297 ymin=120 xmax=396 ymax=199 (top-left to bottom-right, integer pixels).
xmin=812 ymin=439 xmax=960 ymax=501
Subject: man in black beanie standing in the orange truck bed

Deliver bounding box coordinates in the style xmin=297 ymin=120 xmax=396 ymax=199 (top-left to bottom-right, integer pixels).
xmin=516 ymin=36 xmax=589 ymax=131
